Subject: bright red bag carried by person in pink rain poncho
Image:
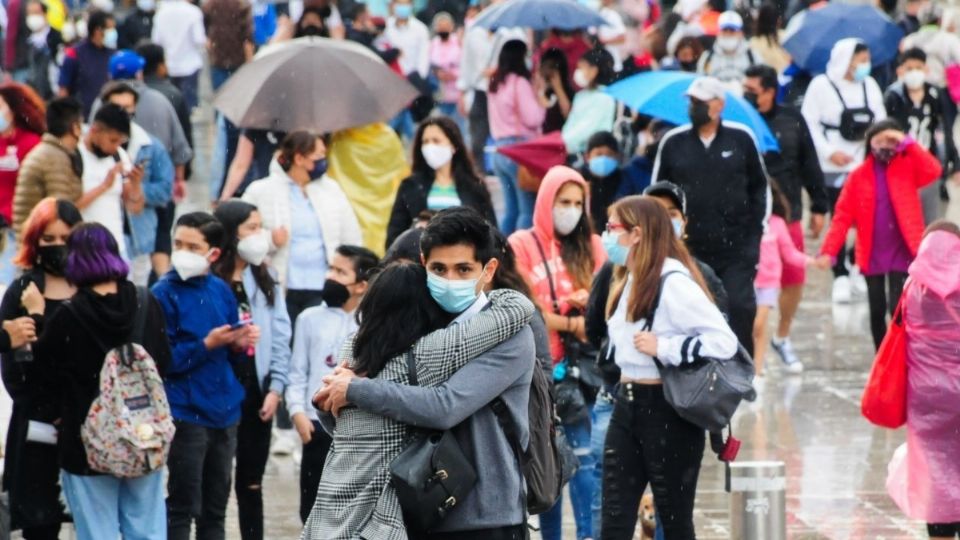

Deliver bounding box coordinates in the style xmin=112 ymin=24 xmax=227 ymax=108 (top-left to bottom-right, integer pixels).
xmin=860 ymin=291 xmax=907 ymax=429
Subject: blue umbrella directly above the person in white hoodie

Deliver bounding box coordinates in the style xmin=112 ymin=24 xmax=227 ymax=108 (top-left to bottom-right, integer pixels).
xmin=783 ymin=2 xmax=903 ymax=73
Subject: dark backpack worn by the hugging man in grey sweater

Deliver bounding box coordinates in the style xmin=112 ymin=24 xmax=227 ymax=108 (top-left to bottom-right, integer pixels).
xmin=490 ymin=365 xmax=577 ymax=515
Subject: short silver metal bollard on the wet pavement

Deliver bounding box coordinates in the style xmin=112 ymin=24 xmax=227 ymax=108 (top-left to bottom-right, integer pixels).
xmin=729 ymin=461 xmax=787 ymax=540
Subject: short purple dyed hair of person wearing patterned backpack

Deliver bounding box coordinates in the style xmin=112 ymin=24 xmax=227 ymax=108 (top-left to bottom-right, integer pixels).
xmin=66 ymin=223 xmax=130 ymax=287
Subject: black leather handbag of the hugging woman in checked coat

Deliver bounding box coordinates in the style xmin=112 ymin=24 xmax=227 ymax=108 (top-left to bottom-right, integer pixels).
xmin=390 ymin=352 xmax=477 ymax=532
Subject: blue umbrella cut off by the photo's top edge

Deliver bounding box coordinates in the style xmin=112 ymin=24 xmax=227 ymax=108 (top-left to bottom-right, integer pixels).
xmin=476 ymin=0 xmax=607 ymax=30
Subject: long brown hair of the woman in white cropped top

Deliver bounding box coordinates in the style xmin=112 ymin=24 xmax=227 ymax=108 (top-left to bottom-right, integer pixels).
xmin=607 ymin=195 xmax=712 ymax=322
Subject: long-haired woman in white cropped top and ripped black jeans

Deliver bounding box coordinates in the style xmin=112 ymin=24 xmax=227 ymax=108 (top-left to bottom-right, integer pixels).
xmin=600 ymin=196 xmax=737 ymax=540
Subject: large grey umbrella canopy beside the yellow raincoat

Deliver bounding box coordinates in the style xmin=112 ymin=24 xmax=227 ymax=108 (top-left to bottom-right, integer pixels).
xmin=213 ymin=37 xmax=418 ymax=132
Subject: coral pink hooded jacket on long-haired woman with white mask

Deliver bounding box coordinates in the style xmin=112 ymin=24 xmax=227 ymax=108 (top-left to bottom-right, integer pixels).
xmin=510 ymin=165 xmax=607 ymax=362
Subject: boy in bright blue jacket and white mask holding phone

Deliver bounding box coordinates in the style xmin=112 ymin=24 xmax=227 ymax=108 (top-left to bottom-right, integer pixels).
xmin=152 ymin=212 xmax=259 ymax=540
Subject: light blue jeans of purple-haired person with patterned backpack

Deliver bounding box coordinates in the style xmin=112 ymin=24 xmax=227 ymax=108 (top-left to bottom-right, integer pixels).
xmin=60 ymin=470 xmax=167 ymax=540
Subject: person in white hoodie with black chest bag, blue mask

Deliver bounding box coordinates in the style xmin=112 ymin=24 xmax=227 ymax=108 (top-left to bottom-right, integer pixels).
xmin=800 ymin=38 xmax=887 ymax=303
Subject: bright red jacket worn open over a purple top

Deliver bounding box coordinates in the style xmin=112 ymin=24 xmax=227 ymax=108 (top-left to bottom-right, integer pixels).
xmin=820 ymin=142 xmax=941 ymax=272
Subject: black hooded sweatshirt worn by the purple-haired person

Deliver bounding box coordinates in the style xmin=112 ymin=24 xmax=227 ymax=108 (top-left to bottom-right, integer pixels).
xmin=36 ymin=281 xmax=170 ymax=475
